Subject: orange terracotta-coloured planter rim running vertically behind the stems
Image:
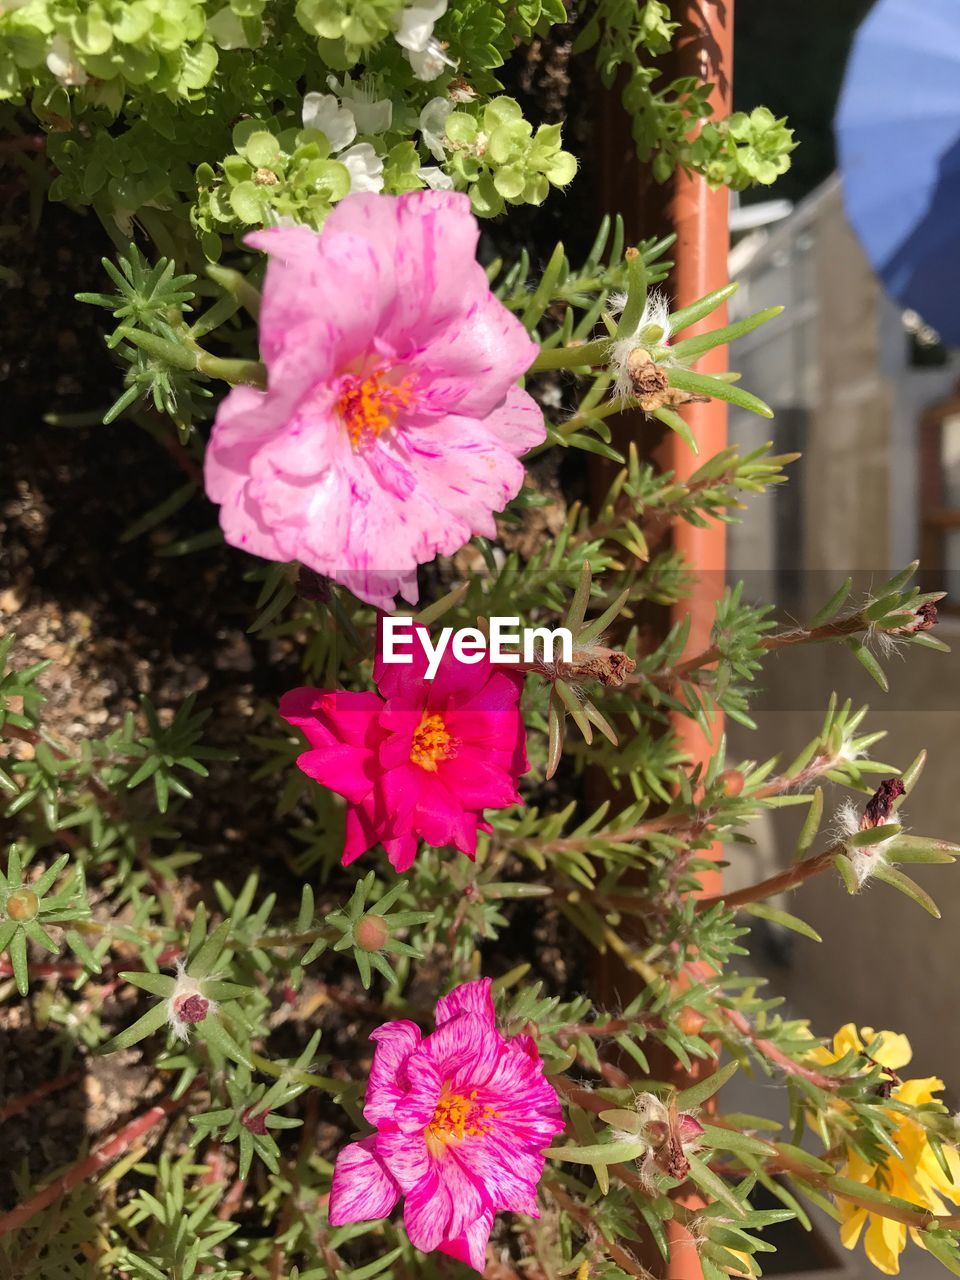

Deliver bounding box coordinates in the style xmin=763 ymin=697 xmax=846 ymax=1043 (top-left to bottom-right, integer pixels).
xmin=662 ymin=0 xmax=733 ymax=1280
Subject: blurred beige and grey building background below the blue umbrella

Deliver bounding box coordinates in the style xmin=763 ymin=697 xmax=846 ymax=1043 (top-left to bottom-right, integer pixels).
xmin=728 ymin=178 xmax=960 ymax=1103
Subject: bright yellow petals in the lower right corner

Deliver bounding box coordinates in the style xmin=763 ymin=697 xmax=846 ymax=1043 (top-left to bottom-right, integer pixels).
xmin=810 ymin=1023 xmax=960 ymax=1276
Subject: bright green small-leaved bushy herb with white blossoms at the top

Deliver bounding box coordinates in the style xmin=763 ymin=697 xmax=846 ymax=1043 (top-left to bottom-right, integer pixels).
xmin=0 ymin=0 xmax=792 ymax=299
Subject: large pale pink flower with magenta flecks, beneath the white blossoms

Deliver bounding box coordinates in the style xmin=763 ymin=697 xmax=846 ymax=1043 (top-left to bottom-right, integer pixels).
xmin=205 ymin=191 xmax=545 ymax=608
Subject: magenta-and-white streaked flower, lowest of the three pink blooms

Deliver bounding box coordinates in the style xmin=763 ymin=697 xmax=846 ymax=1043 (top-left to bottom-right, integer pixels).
xmin=330 ymin=978 xmax=563 ymax=1272
